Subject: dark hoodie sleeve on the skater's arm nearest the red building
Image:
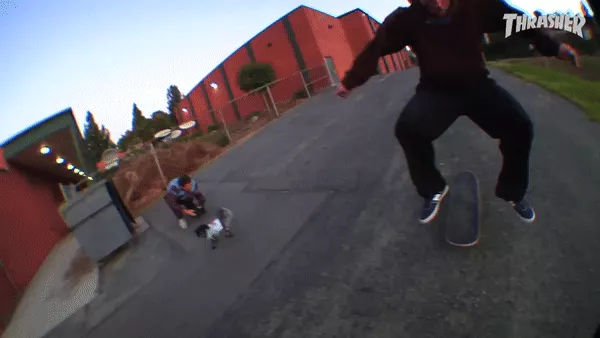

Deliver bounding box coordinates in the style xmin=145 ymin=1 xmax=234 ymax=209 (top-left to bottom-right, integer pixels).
xmin=341 ymin=7 xmax=408 ymax=90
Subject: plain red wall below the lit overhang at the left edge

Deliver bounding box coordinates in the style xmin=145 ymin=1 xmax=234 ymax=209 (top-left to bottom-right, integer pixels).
xmin=0 ymin=166 xmax=68 ymax=326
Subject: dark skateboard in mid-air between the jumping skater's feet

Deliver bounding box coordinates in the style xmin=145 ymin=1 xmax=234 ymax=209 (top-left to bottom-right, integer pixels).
xmin=445 ymin=171 xmax=481 ymax=247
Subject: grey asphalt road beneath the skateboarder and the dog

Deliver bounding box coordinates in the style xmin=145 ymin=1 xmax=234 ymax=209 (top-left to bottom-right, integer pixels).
xmin=45 ymin=70 xmax=600 ymax=338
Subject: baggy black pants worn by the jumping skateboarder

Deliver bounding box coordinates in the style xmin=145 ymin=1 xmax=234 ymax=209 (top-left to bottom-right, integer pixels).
xmin=395 ymin=78 xmax=533 ymax=201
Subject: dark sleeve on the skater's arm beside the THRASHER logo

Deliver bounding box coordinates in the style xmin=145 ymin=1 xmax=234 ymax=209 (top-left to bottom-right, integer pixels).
xmin=480 ymin=0 xmax=561 ymax=56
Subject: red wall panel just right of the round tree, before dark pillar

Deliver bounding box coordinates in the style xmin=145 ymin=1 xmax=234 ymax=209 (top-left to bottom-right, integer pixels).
xmin=250 ymin=21 xmax=302 ymax=102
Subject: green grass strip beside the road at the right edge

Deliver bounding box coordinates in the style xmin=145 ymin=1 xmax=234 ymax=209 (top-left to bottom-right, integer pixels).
xmin=490 ymin=57 xmax=600 ymax=122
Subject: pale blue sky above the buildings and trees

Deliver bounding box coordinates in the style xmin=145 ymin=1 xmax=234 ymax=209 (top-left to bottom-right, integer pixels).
xmin=0 ymin=0 xmax=592 ymax=142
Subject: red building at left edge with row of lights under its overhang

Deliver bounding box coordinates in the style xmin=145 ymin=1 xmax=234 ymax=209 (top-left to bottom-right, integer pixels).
xmin=0 ymin=109 xmax=90 ymax=333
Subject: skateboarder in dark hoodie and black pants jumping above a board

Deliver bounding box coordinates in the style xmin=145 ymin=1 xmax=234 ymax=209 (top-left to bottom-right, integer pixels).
xmin=338 ymin=0 xmax=579 ymax=223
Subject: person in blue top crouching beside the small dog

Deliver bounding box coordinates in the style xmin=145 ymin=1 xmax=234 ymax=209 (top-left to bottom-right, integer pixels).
xmin=165 ymin=175 xmax=206 ymax=229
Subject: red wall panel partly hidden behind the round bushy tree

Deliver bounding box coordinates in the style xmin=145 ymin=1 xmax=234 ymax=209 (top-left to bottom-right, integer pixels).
xmin=224 ymin=46 xmax=266 ymax=118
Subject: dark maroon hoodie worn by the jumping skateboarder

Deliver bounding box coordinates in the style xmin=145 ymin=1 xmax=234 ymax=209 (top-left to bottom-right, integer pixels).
xmin=342 ymin=0 xmax=560 ymax=90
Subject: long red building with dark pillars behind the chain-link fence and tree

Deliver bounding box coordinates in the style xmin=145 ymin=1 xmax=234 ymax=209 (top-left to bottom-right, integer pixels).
xmin=178 ymin=6 xmax=411 ymax=130
